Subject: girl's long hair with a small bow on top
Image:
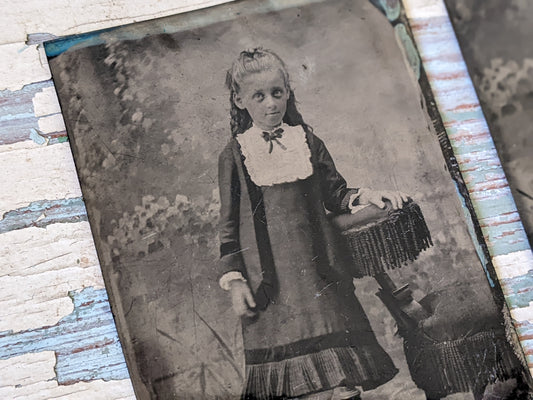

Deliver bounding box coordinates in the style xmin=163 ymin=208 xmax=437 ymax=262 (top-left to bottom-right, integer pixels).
xmin=226 ymin=47 xmax=313 ymax=137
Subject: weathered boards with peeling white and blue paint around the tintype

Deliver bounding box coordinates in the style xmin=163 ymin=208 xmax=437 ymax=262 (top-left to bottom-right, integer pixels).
xmin=0 ymin=0 xmax=533 ymax=399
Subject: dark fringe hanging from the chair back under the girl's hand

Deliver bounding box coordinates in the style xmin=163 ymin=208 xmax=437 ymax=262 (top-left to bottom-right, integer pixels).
xmin=342 ymin=201 xmax=433 ymax=278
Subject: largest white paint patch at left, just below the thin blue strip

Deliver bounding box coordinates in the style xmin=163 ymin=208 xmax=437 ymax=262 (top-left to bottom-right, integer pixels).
xmin=0 ymin=222 xmax=104 ymax=332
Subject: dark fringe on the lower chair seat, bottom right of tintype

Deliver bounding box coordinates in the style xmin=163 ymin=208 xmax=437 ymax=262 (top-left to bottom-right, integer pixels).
xmin=404 ymin=331 xmax=516 ymax=398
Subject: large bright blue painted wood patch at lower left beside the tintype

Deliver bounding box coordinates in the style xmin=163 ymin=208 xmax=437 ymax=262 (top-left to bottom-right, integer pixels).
xmin=0 ymin=288 xmax=129 ymax=385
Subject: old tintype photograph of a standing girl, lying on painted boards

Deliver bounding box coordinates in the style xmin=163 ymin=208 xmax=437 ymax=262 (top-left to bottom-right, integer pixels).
xmin=46 ymin=0 xmax=530 ymax=400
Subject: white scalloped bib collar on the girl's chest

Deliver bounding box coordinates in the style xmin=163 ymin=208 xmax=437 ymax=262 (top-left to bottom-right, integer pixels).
xmin=236 ymin=124 xmax=313 ymax=186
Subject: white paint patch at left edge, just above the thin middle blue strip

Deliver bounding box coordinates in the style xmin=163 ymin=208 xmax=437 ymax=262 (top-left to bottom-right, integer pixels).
xmin=0 ymin=143 xmax=81 ymax=217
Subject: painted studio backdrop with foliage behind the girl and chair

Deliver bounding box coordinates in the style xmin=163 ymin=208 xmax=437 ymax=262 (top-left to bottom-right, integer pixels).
xmin=46 ymin=0 xmax=498 ymax=399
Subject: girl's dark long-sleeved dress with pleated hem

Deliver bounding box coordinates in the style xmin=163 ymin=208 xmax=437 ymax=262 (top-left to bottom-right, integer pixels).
xmin=219 ymin=126 xmax=397 ymax=399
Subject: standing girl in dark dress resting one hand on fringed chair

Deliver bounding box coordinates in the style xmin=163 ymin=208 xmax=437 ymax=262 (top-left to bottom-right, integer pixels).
xmin=219 ymin=49 xmax=407 ymax=399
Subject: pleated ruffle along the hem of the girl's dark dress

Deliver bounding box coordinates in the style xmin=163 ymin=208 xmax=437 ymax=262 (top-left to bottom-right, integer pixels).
xmin=243 ymin=346 xmax=398 ymax=400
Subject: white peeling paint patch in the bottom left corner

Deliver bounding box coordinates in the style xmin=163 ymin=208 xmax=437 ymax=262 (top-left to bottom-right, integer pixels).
xmin=0 ymin=351 xmax=135 ymax=400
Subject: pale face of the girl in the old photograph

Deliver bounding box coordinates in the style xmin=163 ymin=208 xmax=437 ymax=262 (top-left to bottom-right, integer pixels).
xmin=234 ymin=70 xmax=289 ymax=131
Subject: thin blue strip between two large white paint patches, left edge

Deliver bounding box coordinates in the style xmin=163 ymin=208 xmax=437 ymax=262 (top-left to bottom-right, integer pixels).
xmin=0 ymin=197 xmax=87 ymax=233
